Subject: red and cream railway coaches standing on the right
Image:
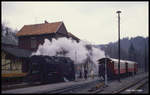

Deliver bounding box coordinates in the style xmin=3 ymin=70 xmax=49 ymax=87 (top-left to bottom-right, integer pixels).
xmin=98 ymin=58 xmax=138 ymax=79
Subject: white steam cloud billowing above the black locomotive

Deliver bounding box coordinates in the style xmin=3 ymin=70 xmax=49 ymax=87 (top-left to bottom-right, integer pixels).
xmin=32 ymin=37 xmax=104 ymax=74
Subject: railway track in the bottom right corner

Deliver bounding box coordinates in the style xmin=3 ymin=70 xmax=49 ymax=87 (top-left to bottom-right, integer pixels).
xmin=112 ymin=76 xmax=148 ymax=94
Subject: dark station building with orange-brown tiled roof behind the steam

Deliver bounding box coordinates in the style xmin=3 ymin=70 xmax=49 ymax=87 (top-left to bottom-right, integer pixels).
xmin=16 ymin=21 xmax=80 ymax=51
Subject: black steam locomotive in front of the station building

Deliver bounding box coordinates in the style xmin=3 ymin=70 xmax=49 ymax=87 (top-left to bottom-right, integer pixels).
xmin=26 ymin=55 xmax=75 ymax=83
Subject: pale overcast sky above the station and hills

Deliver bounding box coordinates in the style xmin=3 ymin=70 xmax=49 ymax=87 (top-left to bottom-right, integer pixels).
xmin=2 ymin=2 xmax=149 ymax=44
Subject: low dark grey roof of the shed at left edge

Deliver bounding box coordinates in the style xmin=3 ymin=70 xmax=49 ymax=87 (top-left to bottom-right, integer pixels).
xmin=1 ymin=46 xmax=32 ymax=57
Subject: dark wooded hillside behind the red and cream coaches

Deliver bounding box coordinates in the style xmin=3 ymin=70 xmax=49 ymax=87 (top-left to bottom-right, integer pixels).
xmin=96 ymin=36 xmax=149 ymax=70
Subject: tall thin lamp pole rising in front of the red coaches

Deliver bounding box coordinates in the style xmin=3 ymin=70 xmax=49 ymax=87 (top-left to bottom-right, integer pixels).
xmin=116 ymin=11 xmax=121 ymax=82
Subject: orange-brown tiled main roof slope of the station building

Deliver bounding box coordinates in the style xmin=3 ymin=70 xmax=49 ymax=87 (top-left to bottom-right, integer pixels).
xmin=16 ymin=22 xmax=63 ymax=36
